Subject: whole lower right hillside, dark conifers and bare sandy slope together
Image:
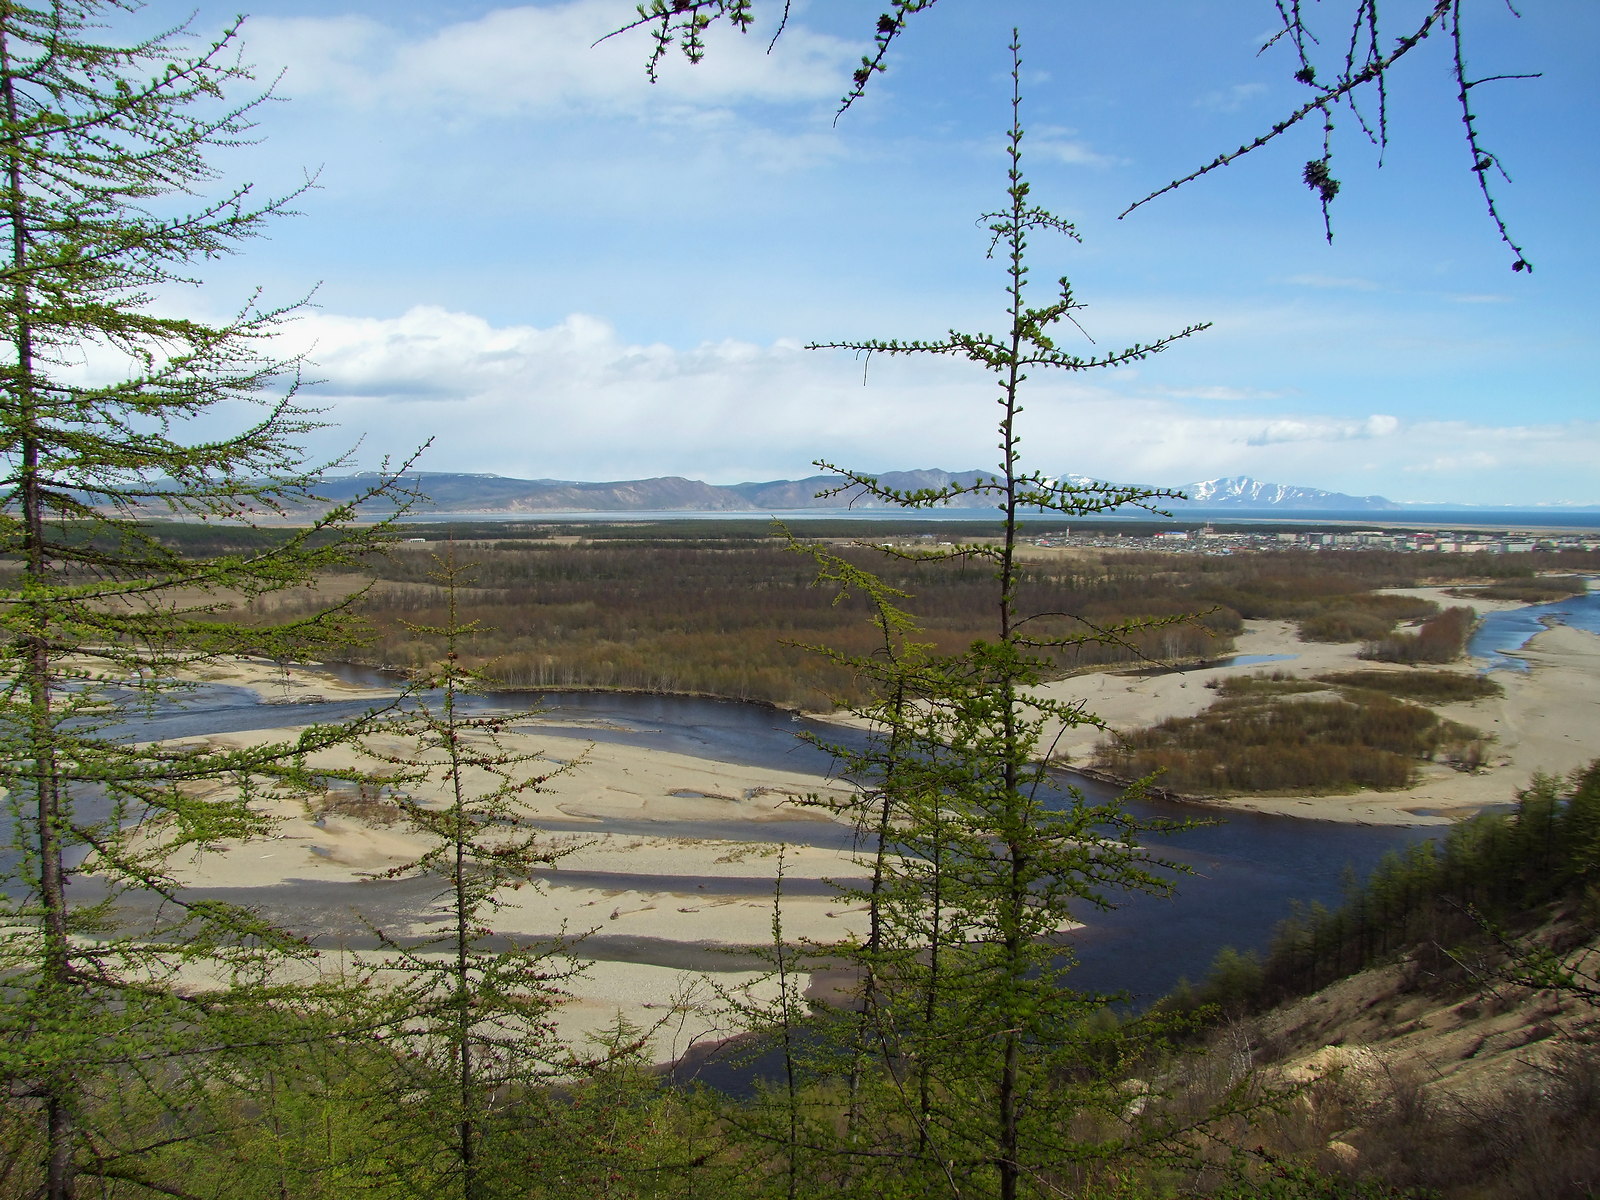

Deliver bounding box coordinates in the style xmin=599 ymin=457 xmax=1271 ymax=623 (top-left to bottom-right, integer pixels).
xmin=1160 ymin=760 xmax=1600 ymax=1200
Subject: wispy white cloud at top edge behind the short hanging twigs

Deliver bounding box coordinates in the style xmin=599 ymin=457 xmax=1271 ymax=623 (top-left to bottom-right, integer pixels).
xmin=245 ymin=0 xmax=859 ymax=120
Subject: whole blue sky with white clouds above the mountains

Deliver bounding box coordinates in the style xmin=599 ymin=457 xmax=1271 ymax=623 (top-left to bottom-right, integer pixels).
xmin=156 ymin=0 xmax=1600 ymax=504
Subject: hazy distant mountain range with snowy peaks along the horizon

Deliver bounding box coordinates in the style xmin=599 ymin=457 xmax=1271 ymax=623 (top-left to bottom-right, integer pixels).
xmin=318 ymin=470 xmax=1587 ymax=514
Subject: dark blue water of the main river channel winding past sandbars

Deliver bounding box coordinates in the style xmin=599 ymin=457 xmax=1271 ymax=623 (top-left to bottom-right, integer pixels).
xmin=121 ymin=667 xmax=1429 ymax=1002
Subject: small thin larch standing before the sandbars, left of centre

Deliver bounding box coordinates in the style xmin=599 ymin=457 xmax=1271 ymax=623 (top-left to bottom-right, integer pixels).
xmin=362 ymin=552 xmax=585 ymax=1200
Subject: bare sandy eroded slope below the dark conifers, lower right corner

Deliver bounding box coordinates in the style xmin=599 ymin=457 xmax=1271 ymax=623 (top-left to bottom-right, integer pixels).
xmin=1214 ymin=915 xmax=1600 ymax=1200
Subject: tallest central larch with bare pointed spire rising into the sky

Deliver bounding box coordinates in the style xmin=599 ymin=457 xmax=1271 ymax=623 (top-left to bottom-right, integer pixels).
xmin=818 ymin=40 xmax=1205 ymax=1200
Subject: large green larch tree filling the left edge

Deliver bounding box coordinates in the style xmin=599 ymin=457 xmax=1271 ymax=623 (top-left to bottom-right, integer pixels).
xmin=0 ymin=0 xmax=419 ymax=1200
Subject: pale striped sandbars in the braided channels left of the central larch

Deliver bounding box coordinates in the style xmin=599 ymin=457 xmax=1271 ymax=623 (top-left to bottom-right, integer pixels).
xmin=148 ymin=661 xmax=862 ymax=1061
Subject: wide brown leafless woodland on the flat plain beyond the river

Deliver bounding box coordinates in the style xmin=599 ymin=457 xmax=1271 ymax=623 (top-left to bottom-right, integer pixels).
xmin=249 ymin=544 xmax=1587 ymax=710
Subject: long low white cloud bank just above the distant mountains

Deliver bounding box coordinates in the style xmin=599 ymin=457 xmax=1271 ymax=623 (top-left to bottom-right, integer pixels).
xmin=249 ymin=307 xmax=1600 ymax=502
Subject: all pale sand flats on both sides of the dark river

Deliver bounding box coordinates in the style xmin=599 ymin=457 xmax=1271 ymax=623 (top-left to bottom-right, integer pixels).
xmin=159 ymin=594 xmax=1600 ymax=1059
